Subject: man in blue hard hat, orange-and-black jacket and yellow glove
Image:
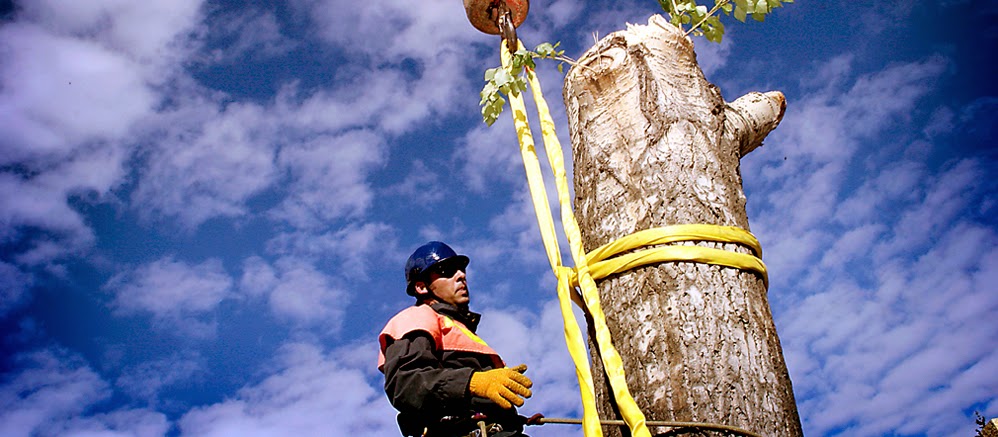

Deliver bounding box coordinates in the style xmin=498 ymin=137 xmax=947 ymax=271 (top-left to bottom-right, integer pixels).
xmin=378 ymin=241 xmax=533 ymax=437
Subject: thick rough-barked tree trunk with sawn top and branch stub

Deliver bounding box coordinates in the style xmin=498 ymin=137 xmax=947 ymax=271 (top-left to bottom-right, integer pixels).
xmin=564 ymin=15 xmax=802 ymax=437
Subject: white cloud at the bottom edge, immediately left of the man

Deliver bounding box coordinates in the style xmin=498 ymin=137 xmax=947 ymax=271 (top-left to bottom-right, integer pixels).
xmin=179 ymin=343 xmax=398 ymax=437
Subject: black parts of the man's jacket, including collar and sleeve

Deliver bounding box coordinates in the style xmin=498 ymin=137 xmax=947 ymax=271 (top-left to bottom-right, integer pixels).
xmin=383 ymin=303 xmax=522 ymax=435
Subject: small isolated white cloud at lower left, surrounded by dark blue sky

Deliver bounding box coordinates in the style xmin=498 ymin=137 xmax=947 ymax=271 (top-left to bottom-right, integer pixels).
xmin=104 ymin=257 xmax=233 ymax=338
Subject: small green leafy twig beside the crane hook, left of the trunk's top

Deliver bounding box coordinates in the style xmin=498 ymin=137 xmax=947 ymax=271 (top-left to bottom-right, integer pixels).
xmin=479 ymin=42 xmax=575 ymax=126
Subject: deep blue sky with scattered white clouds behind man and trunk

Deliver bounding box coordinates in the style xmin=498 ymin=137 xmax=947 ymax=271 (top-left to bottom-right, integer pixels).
xmin=0 ymin=0 xmax=998 ymax=436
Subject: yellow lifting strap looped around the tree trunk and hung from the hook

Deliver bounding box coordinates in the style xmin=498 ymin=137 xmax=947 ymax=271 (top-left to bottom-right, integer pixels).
xmin=500 ymin=41 xmax=766 ymax=437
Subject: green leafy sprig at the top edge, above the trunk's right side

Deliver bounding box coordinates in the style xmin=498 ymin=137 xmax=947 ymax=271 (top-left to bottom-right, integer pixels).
xmin=658 ymin=0 xmax=794 ymax=43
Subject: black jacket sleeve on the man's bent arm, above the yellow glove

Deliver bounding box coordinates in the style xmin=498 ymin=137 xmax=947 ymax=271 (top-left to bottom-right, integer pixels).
xmin=384 ymin=331 xmax=474 ymax=418
